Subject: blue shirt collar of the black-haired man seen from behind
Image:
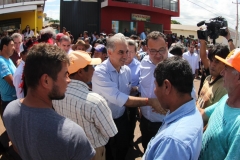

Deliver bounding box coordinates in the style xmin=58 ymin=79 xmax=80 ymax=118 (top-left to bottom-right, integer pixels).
xmin=164 ymin=99 xmax=196 ymax=124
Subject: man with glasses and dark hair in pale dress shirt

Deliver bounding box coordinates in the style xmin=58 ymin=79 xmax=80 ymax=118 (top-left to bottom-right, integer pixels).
xmin=139 ymin=31 xmax=172 ymax=150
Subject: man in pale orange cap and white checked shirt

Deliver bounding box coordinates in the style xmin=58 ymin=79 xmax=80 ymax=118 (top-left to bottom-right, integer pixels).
xmin=53 ymin=51 xmax=117 ymax=160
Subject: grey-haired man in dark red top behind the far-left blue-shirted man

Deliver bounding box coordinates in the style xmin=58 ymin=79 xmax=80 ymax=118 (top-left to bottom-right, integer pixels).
xmin=10 ymin=33 xmax=23 ymax=67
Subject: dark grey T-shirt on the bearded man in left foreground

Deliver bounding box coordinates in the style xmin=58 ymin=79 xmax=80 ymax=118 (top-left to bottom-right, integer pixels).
xmin=3 ymin=99 xmax=95 ymax=160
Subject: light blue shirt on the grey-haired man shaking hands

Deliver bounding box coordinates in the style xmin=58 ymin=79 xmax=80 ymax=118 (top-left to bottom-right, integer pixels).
xmin=92 ymin=58 xmax=132 ymax=119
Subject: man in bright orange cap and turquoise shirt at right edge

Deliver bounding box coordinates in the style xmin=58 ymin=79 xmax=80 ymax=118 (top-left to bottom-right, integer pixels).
xmin=199 ymin=48 xmax=240 ymax=160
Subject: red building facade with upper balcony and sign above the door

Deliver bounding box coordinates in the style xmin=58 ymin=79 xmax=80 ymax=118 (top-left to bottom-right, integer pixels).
xmin=101 ymin=0 xmax=180 ymax=34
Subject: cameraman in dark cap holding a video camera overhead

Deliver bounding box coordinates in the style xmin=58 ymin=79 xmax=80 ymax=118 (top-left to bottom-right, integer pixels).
xmin=197 ymin=30 xmax=234 ymax=124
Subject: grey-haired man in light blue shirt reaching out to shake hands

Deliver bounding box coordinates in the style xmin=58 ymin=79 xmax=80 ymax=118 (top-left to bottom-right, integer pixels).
xmin=92 ymin=34 xmax=161 ymax=160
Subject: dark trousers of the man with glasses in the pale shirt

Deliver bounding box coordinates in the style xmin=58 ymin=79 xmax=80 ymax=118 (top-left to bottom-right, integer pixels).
xmin=140 ymin=116 xmax=162 ymax=151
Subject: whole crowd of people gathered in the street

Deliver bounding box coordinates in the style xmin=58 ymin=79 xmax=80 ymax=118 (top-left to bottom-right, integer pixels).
xmin=0 ymin=26 xmax=240 ymax=160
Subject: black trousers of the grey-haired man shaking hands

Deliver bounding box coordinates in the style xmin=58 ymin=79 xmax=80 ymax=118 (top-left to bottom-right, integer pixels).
xmin=105 ymin=111 xmax=130 ymax=160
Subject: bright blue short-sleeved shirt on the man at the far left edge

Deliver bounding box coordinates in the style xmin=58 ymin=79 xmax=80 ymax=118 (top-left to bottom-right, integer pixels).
xmin=0 ymin=56 xmax=17 ymax=101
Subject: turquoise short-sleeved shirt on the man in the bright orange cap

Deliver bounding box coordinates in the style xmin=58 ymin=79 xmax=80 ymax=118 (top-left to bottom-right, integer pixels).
xmin=199 ymin=95 xmax=240 ymax=160
